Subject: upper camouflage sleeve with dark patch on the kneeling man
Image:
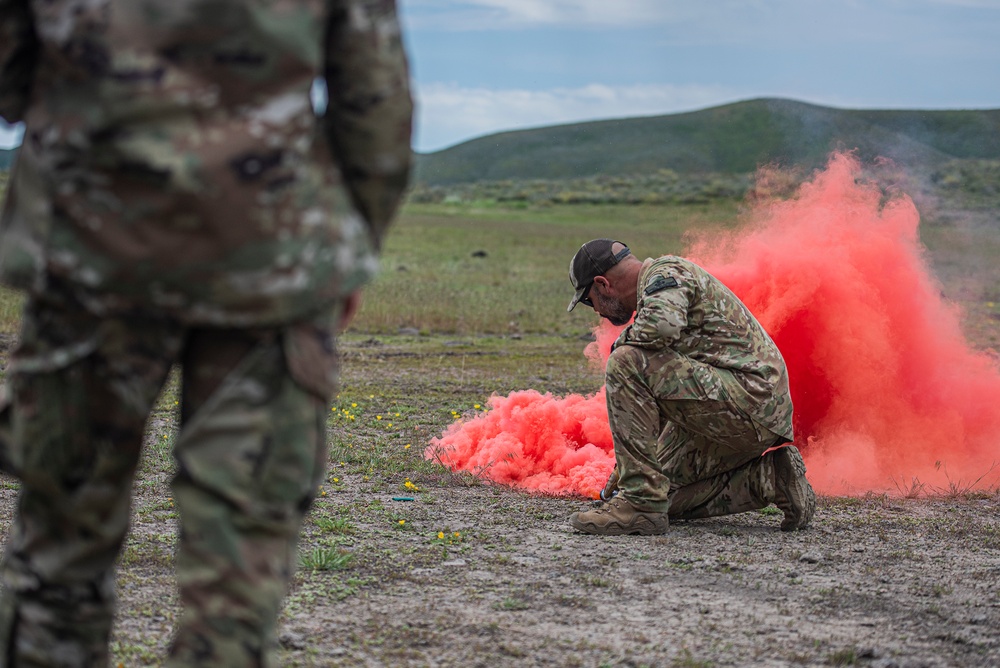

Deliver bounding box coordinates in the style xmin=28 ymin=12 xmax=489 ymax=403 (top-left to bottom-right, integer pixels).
xmin=622 ymin=274 xmax=692 ymax=350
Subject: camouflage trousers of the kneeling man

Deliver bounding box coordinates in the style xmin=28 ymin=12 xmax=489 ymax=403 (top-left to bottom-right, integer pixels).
xmin=606 ymin=345 xmax=786 ymax=519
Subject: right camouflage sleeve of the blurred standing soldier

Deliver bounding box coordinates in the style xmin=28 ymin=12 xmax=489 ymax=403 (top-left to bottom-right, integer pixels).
xmin=323 ymin=0 xmax=413 ymax=249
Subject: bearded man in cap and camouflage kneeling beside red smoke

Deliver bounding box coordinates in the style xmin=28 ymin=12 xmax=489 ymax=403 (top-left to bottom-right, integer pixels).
xmin=568 ymin=239 xmax=816 ymax=535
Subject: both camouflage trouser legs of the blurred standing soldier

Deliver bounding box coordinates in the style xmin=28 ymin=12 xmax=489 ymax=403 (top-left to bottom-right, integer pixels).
xmin=0 ymin=300 xmax=337 ymax=668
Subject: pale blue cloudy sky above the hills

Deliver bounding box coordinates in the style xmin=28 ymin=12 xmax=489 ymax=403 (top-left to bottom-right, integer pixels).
xmin=0 ymin=0 xmax=1000 ymax=152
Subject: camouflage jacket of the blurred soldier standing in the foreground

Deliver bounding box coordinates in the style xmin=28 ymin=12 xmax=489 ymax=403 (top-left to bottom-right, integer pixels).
xmin=0 ymin=0 xmax=412 ymax=325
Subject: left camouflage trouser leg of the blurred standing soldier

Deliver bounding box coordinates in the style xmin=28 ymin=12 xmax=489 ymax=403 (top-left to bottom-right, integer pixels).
xmin=0 ymin=300 xmax=181 ymax=668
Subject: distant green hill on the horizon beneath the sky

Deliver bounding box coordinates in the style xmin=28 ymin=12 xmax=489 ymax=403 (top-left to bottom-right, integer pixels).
xmin=415 ymin=99 xmax=1000 ymax=185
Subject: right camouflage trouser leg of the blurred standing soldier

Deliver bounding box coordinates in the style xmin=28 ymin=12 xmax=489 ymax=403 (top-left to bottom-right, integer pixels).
xmin=167 ymin=316 xmax=336 ymax=668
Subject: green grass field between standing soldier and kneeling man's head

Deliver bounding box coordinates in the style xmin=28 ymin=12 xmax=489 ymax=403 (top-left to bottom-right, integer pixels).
xmin=351 ymin=200 xmax=737 ymax=334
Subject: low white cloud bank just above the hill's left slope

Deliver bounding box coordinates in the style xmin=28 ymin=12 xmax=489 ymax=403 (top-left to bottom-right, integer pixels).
xmin=416 ymin=83 xmax=747 ymax=152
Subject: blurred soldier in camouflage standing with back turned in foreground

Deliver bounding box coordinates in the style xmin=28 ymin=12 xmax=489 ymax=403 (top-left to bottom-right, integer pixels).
xmin=0 ymin=0 xmax=412 ymax=667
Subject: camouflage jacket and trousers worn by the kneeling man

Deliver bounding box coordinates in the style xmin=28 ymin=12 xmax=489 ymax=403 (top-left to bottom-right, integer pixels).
xmin=607 ymin=256 xmax=792 ymax=519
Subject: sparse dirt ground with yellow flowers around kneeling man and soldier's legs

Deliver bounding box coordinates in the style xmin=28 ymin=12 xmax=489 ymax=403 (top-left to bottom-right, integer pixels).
xmin=0 ymin=337 xmax=976 ymax=668
